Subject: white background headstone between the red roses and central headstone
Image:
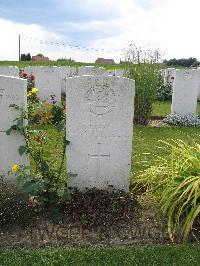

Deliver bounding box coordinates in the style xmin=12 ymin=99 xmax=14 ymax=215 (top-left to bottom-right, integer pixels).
xmin=24 ymin=66 xmax=62 ymax=104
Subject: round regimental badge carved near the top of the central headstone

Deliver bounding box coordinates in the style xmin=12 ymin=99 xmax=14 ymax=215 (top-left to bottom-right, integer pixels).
xmin=86 ymin=84 xmax=116 ymax=115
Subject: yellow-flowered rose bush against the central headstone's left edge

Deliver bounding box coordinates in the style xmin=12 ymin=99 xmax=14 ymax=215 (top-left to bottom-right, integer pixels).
xmin=6 ymin=104 xmax=71 ymax=206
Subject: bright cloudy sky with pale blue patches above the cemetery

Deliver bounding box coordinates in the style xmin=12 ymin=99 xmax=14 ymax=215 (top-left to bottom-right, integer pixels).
xmin=0 ymin=0 xmax=200 ymax=62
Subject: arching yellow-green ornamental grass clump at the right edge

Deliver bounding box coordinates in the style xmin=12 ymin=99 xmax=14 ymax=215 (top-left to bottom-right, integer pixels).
xmin=134 ymin=140 xmax=200 ymax=240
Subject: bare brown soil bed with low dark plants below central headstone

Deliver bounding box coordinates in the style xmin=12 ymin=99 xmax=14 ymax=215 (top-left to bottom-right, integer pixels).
xmin=0 ymin=186 xmax=170 ymax=248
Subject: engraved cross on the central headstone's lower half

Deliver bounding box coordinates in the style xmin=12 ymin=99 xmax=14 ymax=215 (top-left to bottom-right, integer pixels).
xmin=88 ymin=143 xmax=110 ymax=178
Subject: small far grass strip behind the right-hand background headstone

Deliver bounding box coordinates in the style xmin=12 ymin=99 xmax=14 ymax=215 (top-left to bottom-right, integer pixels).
xmin=151 ymin=101 xmax=200 ymax=117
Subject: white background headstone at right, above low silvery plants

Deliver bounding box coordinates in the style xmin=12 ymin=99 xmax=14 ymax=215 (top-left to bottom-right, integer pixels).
xmin=171 ymin=69 xmax=200 ymax=115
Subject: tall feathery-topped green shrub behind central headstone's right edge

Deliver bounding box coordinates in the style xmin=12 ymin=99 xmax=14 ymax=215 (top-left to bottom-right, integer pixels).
xmin=125 ymin=45 xmax=160 ymax=125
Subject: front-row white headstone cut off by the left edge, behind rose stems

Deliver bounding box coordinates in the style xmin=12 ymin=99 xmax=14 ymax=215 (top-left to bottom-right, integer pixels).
xmin=0 ymin=76 xmax=28 ymax=180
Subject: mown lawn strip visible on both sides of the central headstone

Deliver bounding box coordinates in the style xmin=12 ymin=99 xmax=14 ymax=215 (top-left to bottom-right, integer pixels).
xmin=29 ymin=126 xmax=200 ymax=181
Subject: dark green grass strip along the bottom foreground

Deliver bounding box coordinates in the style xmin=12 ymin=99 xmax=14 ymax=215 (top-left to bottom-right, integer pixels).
xmin=0 ymin=245 xmax=200 ymax=266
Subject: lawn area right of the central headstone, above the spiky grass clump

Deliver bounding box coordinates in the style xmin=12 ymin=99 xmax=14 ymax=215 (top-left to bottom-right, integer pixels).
xmin=132 ymin=126 xmax=200 ymax=177
